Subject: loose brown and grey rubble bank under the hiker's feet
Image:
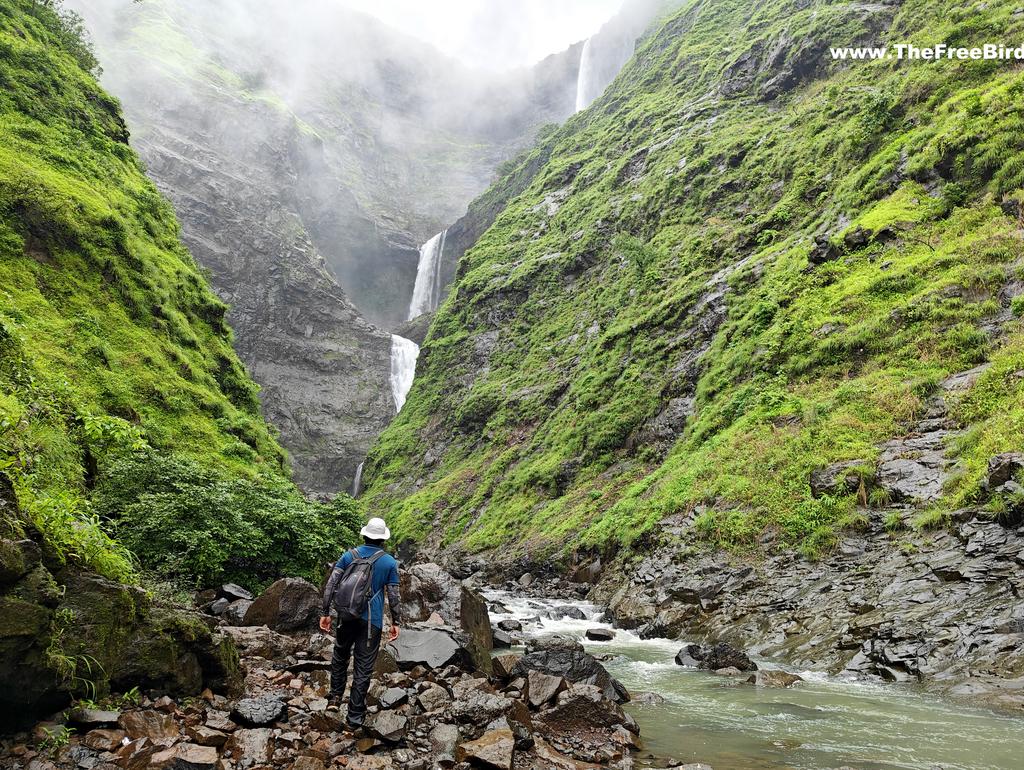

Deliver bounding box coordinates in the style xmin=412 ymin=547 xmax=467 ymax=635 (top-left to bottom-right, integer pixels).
xmin=0 ymin=561 xmax=637 ymax=770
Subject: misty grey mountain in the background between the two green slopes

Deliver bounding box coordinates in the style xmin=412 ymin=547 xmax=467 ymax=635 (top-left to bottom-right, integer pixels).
xmin=72 ymin=0 xmax=593 ymax=495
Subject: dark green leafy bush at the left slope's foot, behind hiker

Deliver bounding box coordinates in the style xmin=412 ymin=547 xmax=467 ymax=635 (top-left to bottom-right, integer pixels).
xmin=94 ymin=454 xmax=358 ymax=587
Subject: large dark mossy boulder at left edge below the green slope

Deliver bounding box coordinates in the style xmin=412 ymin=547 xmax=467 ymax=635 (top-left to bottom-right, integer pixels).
xmin=0 ymin=528 xmax=239 ymax=726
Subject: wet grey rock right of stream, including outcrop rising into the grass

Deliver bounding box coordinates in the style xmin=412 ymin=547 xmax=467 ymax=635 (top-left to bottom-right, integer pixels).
xmin=590 ymin=365 xmax=1024 ymax=710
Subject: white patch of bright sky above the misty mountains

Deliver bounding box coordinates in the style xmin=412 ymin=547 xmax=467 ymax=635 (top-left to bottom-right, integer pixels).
xmin=337 ymin=0 xmax=623 ymax=70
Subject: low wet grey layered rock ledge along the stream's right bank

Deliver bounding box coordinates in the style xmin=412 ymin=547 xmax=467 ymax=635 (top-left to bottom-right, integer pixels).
xmin=592 ymin=509 xmax=1024 ymax=708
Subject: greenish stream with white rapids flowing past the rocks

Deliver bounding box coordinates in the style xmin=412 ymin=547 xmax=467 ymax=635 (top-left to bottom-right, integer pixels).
xmin=485 ymin=591 xmax=1024 ymax=770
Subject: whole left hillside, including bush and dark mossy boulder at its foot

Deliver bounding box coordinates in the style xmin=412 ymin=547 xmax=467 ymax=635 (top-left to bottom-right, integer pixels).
xmin=0 ymin=0 xmax=368 ymax=728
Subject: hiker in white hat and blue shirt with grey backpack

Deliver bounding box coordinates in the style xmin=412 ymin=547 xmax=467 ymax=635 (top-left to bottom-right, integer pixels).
xmin=319 ymin=518 xmax=401 ymax=730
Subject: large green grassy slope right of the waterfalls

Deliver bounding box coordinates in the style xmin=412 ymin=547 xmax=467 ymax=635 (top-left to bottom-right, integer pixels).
xmin=367 ymin=0 xmax=1024 ymax=554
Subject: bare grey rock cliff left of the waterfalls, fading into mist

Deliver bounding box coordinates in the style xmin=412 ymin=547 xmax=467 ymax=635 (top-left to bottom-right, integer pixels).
xmin=117 ymin=83 xmax=395 ymax=496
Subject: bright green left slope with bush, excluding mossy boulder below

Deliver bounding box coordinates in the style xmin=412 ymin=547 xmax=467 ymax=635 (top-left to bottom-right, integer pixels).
xmin=0 ymin=0 xmax=350 ymax=580
